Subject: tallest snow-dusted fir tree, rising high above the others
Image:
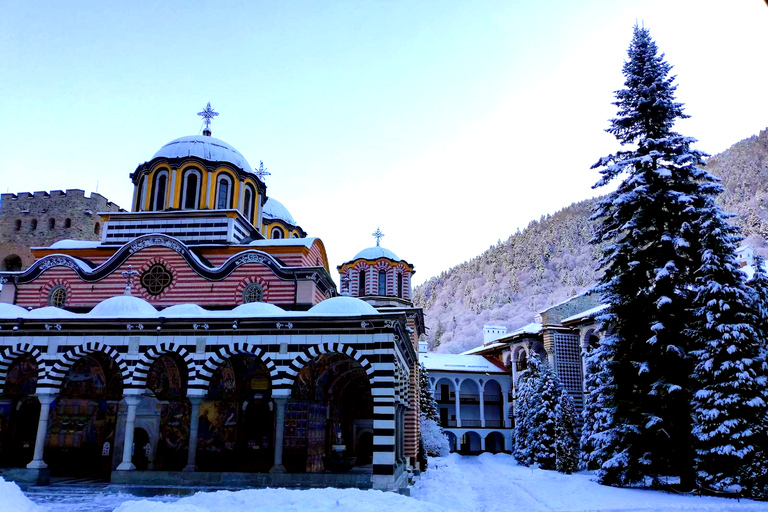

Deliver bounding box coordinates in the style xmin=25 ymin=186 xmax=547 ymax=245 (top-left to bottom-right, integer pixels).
xmin=592 ymin=26 xmax=717 ymax=486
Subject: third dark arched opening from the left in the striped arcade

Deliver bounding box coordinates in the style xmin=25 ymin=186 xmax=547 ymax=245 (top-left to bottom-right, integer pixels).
xmin=146 ymin=354 xmax=191 ymax=471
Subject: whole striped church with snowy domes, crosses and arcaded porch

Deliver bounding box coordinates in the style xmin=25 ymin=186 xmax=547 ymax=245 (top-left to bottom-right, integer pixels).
xmin=0 ymin=109 xmax=424 ymax=490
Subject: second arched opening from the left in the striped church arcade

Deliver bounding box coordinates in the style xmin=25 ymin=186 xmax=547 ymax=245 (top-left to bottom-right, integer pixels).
xmin=44 ymin=352 xmax=123 ymax=477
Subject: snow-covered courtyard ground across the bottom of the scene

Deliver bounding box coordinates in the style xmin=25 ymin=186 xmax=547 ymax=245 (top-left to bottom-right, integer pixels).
xmin=0 ymin=454 xmax=768 ymax=512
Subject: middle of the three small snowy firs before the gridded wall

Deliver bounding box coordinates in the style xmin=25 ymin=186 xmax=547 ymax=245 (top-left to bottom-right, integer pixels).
xmin=529 ymin=363 xmax=563 ymax=469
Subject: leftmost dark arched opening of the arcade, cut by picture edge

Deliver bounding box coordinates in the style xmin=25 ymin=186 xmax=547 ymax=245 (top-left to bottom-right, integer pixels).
xmin=0 ymin=355 xmax=40 ymax=467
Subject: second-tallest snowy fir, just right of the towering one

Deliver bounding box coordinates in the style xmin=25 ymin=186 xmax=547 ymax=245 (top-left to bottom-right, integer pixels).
xmin=692 ymin=203 xmax=768 ymax=495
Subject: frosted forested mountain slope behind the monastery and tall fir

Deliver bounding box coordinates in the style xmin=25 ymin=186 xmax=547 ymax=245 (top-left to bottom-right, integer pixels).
xmin=414 ymin=129 xmax=768 ymax=353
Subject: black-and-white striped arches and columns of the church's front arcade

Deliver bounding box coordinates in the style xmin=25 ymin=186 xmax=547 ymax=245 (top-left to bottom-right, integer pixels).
xmin=0 ymin=322 xmax=415 ymax=489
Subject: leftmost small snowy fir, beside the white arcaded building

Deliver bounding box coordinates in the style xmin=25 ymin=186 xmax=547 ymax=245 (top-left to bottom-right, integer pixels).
xmin=512 ymin=353 xmax=541 ymax=466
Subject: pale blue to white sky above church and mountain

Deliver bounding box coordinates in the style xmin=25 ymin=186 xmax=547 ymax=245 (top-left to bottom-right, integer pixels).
xmin=0 ymin=0 xmax=768 ymax=282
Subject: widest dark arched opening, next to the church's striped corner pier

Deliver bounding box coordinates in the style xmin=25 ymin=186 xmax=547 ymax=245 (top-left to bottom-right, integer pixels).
xmin=283 ymin=354 xmax=373 ymax=473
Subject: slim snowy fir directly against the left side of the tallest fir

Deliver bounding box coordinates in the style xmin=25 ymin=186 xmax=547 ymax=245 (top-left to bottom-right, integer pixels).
xmin=579 ymin=336 xmax=613 ymax=470
